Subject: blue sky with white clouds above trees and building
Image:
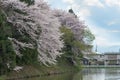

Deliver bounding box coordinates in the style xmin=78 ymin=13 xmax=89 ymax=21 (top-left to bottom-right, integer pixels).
xmin=45 ymin=0 xmax=120 ymax=53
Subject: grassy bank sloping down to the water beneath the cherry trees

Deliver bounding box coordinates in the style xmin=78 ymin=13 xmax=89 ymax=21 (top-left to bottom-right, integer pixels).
xmin=6 ymin=58 xmax=77 ymax=80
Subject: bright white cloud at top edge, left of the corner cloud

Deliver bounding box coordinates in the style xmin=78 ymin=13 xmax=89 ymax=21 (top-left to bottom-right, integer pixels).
xmin=84 ymin=0 xmax=104 ymax=8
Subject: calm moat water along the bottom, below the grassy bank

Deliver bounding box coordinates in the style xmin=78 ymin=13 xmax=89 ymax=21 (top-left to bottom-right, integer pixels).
xmin=24 ymin=68 xmax=120 ymax=80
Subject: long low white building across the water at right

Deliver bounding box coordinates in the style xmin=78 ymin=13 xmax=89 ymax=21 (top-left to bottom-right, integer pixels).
xmin=84 ymin=52 xmax=120 ymax=65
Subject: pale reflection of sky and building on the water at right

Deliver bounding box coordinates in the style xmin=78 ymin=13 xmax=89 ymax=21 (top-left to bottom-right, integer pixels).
xmin=74 ymin=68 xmax=120 ymax=80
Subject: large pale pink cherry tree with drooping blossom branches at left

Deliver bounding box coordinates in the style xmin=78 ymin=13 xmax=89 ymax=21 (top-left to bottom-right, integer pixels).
xmin=1 ymin=0 xmax=63 ymax=65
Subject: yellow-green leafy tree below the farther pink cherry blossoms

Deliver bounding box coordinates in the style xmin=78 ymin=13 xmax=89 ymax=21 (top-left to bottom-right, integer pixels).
xmin=60 ymin=27 xmax=84 ymax=65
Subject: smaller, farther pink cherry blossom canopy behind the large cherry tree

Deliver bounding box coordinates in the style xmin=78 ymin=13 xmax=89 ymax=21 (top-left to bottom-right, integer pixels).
xmin=54 ymin=10 xmax=87 ymax=41
